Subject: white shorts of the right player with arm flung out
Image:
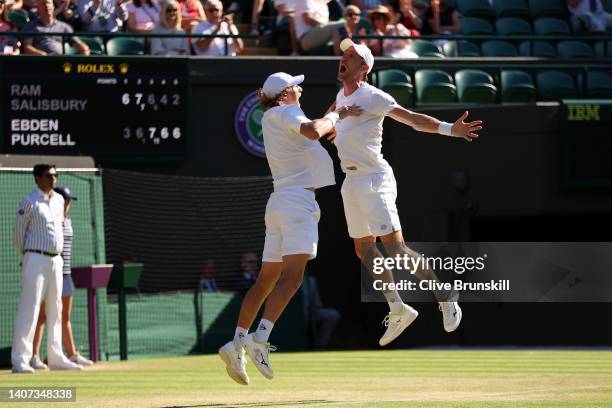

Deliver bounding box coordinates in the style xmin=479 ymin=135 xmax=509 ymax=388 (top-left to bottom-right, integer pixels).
xmin=341 ymin=169 xmax=402 ymax=238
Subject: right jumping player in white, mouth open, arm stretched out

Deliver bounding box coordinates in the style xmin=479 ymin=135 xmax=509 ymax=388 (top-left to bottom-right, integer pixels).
xmin=330 ymin=39 xmax=482 ymax=346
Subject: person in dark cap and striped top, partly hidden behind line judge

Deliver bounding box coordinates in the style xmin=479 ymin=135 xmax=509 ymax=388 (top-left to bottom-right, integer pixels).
xmin=30 ymin=187 xmax=93 ymax=370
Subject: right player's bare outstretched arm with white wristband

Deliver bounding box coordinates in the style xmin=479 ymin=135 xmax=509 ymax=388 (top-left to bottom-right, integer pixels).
xmin=387 ymin=106 xmax=482 ymax=142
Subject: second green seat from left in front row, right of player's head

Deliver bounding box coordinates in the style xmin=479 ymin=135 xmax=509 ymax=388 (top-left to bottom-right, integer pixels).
xmin=414 ymin=69 xmax=457 ymax=104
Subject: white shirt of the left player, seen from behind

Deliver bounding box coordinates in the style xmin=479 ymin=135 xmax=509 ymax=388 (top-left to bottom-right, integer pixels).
xmin=261 ymin=104 xmax=336 ymax=190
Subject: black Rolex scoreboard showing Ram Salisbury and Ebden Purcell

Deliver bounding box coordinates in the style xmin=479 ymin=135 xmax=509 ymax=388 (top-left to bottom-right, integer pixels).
xmin=0 ymin=57 xmax=191 ymax=160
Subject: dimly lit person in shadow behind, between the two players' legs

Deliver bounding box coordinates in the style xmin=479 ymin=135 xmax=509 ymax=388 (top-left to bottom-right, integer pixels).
xmin=302 ymin=274 xmax=340 ymax=348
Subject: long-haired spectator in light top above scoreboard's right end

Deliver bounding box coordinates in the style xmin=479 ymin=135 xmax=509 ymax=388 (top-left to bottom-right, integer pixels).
xmin=151 ymin=0 xmax=191 ymax=55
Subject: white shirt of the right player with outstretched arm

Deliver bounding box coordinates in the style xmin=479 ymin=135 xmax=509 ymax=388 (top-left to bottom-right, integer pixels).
xmin=334 ymin=82 xmax=399 ymax=175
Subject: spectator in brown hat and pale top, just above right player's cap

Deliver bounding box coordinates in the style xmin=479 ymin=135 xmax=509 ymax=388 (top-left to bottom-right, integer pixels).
xmin=366 ymin=6 xmax=418 ymax=58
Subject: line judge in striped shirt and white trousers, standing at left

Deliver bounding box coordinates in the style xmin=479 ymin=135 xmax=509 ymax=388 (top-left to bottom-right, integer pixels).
xmin=11 ymin=164 xmax=81 ymax=373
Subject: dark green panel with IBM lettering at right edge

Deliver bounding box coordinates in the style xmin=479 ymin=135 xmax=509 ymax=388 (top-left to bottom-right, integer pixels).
xmin=561 ymin=100 xmax=612 ymax=187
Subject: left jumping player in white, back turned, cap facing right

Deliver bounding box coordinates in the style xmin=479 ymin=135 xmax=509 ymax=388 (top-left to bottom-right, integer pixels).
xmin=219 ymin=72 xmax=361 ymax=385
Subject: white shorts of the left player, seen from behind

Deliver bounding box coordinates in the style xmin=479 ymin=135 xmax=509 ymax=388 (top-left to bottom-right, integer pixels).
xmin=262 ymin=187 xmax=321 ymax=262
